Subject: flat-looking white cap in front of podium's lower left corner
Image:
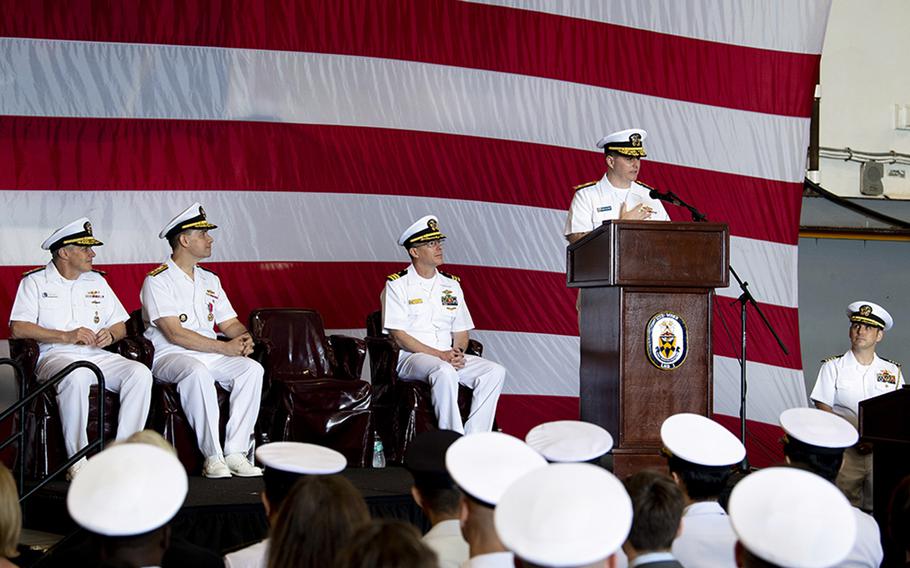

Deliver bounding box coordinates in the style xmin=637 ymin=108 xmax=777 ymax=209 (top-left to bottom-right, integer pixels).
xmin=525 ymin=420 xmax=613 ymax=462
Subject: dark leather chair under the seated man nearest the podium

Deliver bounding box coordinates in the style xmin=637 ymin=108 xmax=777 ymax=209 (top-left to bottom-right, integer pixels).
xmin=365 ymin=310 xmax=483 ymax=463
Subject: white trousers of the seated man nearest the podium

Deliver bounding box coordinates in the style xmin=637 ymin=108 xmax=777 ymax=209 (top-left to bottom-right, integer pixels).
xmin=398 ymin=353 xmax=506 ymax=434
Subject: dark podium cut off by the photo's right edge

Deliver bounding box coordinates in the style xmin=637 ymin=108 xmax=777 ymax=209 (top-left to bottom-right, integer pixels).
xmin=859 ymin=387 xmax=910 ymax=567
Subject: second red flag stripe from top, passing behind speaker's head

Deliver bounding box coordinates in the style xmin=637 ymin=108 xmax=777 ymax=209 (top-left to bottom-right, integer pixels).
xmin=0 ymin=116 xmax=802 ymax=244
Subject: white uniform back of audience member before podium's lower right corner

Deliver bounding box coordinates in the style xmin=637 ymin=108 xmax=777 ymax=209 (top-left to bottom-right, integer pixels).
xmin=673 ymin=501 xmax=736 ymax=568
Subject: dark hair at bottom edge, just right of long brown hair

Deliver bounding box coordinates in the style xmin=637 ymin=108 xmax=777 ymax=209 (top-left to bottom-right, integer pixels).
xmin=335 ymin=519 xmax=437 ymax=568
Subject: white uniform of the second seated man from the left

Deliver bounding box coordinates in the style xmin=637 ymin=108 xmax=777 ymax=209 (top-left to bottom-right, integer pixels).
xmin=141 ymin=258 xmax=264 ymax=457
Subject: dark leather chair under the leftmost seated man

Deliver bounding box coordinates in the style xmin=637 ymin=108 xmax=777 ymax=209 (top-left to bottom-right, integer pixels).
xmin=9 ymin=337 xmax=153 ymax=479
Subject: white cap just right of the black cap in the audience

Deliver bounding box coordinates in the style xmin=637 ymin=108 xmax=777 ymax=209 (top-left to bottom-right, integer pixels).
xmin=446 ymin=432 xmax=547 ymax=507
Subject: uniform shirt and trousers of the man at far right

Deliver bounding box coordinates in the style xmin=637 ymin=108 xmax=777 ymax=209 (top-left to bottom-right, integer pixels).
xmin=810 ymin=350 xmax=904 ymax=510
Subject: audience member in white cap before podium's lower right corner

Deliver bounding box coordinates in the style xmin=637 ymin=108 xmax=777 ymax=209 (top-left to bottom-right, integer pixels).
xmin=660 ymin=414 xmax=746 ymax=568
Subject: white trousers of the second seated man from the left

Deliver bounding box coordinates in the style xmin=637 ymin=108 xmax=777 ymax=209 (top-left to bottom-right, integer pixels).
xmin=152 ymin=349 xmax=264 ymax=458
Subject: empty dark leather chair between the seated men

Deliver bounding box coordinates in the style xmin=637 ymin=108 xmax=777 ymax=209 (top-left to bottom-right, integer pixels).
xmin=249 ymin=308 xmax=373 ymax=467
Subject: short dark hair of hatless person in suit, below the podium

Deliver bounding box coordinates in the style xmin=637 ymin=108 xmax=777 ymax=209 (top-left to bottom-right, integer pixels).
xmin=624 ymin=470 xmax=685 ymax=552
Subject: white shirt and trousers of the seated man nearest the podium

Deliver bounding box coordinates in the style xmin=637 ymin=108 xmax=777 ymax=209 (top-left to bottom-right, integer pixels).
xmin=380 ymin=266 xmax=506 ymax=434
